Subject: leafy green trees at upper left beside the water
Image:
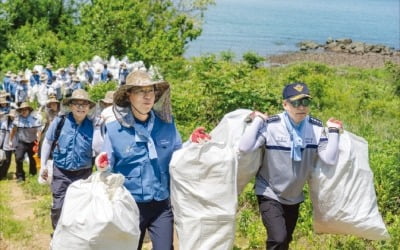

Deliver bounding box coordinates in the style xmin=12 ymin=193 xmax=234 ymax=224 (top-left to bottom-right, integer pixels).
xmin=0 ymin=0 xmax=214 ymax=73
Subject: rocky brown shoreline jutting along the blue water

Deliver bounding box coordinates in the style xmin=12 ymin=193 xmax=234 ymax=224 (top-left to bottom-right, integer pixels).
xmin=267 ymin=38 xmax=400 ymax=68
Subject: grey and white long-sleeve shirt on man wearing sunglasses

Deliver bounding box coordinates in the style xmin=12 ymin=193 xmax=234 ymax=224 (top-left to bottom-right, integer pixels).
xmin=239 ymin=113 xmax=339 ymax=205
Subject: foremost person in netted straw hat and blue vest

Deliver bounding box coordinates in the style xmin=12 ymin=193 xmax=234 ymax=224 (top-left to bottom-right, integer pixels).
xmin=98 ymin=71 xmax=182 ymax=250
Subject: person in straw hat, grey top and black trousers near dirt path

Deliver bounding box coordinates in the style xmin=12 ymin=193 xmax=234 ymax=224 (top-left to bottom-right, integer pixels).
xmin=8 ymin=102 xmax=42 ymax=182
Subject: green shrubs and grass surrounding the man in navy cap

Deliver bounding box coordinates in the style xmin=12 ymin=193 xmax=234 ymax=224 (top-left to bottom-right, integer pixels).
xmin=163 ymin=54 xmax=400 ymax=249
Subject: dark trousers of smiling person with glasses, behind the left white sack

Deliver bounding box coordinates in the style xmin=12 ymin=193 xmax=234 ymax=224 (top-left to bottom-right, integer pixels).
xmin=51 ymin=166 xmax=92 ymax=229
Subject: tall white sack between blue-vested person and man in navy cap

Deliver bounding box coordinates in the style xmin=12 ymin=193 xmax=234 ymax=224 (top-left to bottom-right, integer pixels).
xmin=170 ymin=110 xmax=261 ymax=250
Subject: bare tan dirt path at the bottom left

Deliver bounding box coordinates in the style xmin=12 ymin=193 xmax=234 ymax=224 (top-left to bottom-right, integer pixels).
xmin=2 ymin=180 xmax=50 ymax=250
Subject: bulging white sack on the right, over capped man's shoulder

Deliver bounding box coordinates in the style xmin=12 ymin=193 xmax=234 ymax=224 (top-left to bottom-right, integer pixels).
xmin=309 ymin=131 xmax=389 ymax=240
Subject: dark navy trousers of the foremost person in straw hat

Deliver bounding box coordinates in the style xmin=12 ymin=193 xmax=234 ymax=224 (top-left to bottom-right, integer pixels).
xmin=137 ymin=199 xmax=174 ymax=250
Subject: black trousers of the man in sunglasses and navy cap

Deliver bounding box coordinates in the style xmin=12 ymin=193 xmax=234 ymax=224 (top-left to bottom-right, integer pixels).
xmin=257 ymin=195 xmax=300 ymax=249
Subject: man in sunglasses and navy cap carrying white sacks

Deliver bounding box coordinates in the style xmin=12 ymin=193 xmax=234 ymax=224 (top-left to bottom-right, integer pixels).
xmin=239 ymin=82 xmax=343 ymax=249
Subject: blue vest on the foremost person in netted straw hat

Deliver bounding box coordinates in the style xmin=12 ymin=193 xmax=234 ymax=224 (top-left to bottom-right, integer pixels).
xmin=104 ymin=114 xmax=182 ymax=202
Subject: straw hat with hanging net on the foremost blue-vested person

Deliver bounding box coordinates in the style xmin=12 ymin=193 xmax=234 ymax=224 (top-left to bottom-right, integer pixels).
xmin=114 ymin=70 xmax=172 ymax=122
